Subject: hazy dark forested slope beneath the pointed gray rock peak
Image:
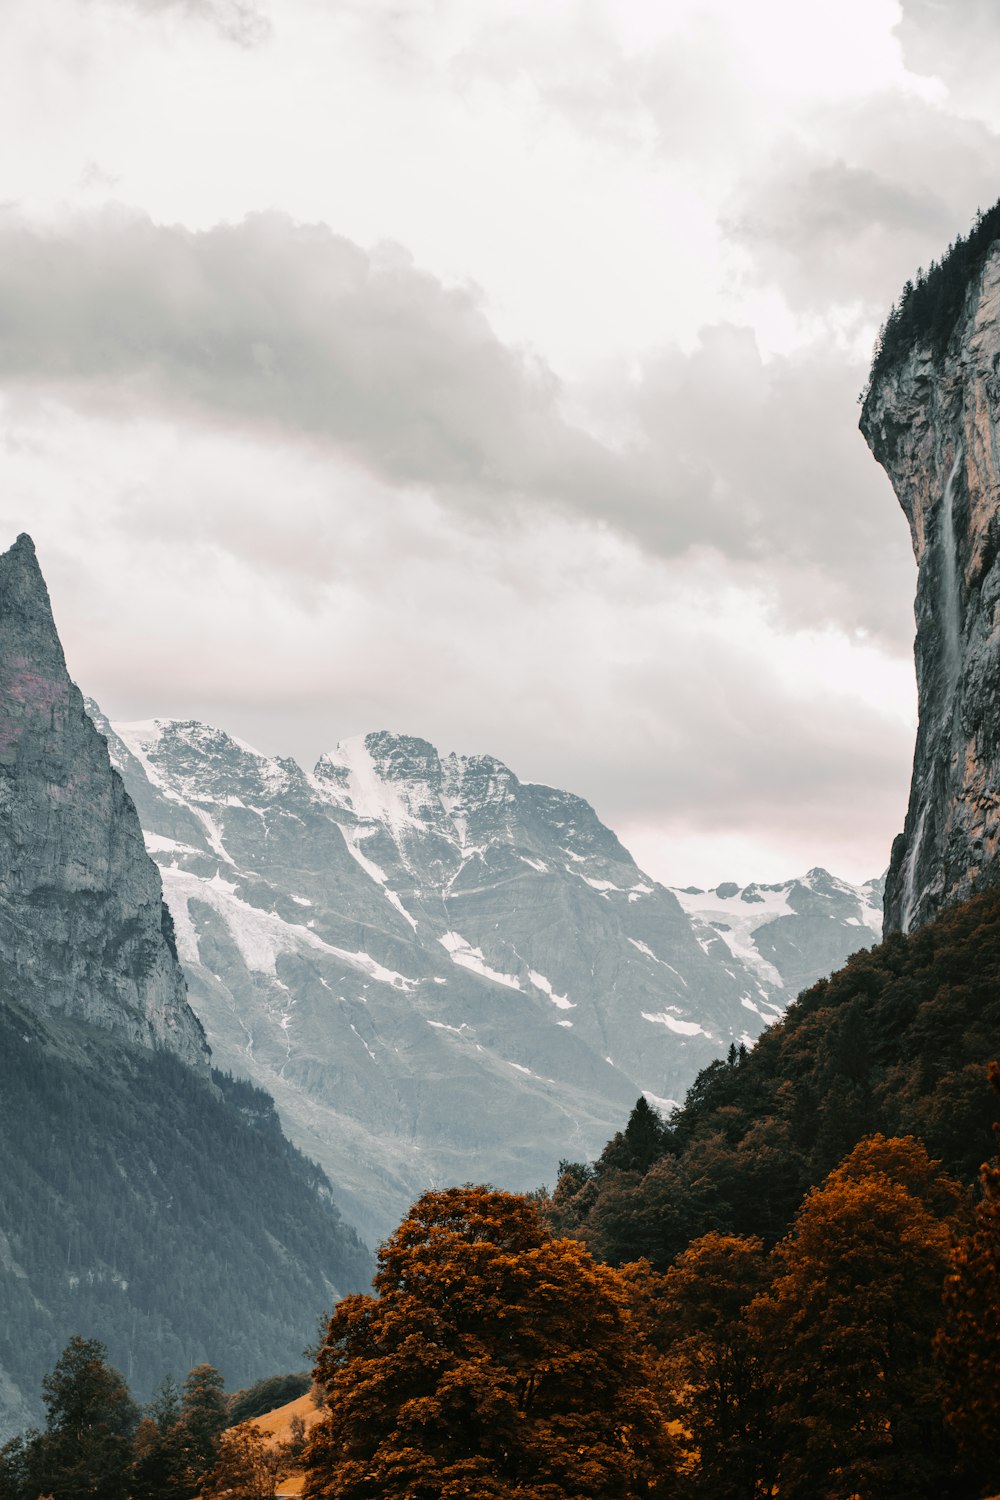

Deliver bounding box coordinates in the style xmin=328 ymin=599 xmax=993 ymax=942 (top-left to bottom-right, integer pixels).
xmin=0 ymin=1004 xmax=372 ymax=1416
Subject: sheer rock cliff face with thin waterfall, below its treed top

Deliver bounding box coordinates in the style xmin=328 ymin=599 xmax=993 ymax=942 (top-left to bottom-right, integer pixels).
xmin=861 ymin=242 xmax=1000 ymax=932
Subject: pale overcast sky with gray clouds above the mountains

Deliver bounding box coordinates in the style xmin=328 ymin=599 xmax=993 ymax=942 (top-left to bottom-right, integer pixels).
xmin=0 ymin=0 xmax=1000 ymax=885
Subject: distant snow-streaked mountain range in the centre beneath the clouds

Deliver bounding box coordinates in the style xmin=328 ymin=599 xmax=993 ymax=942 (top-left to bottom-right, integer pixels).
xmin=91 ymin=705 xmax=874 ymax=1236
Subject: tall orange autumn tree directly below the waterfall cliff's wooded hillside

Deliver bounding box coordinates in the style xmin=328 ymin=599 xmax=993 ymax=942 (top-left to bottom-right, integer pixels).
xmin=751 ymin=1136 xmax=963 ymax=1500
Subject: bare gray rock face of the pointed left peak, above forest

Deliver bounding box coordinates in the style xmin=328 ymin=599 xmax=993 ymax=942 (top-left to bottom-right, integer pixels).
xmin=0 ymin=536 xmax=208 ymax=1070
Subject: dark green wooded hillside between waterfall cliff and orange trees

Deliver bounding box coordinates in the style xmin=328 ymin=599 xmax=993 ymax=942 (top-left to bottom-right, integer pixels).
xmin=549 ymin=893 xmax=1000 ymax=1268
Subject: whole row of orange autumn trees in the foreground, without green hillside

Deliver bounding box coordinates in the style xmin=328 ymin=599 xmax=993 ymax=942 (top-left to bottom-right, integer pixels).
xmin=304 ymin=1164 xmax=1000 ymax=1500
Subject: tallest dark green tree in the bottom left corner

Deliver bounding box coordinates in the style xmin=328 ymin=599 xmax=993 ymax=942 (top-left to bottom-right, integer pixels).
xmin=27 ymin=1337 xmax=139 ymax=1500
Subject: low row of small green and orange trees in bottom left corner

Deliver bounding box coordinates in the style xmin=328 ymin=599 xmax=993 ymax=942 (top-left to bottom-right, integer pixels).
xmin=0 ymin=1335 xmax=310 ymax=1500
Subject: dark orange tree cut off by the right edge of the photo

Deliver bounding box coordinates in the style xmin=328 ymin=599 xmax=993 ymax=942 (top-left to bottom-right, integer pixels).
xmin=936 ymin=1062 xmax=1000 ymax=1494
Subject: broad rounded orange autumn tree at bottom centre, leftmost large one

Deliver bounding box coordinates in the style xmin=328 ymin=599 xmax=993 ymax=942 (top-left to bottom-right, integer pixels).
xmin=306 ymin=1187 xmax=673 ymax=1500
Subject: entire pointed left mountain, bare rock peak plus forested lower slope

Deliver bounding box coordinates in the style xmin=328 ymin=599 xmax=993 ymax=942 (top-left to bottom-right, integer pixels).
xmin=0 ymin=537 xmax=370 ymax=1436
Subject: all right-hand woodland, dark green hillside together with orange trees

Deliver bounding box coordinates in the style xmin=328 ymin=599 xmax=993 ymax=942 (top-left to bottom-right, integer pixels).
xmin=284 ymin=891 xmax=1000 ymax=1500
